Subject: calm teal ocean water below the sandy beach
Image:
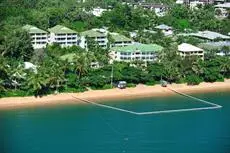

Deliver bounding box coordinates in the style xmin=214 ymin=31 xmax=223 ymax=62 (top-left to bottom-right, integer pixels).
xmin=0 ymin=92 xmax=230 ymax=153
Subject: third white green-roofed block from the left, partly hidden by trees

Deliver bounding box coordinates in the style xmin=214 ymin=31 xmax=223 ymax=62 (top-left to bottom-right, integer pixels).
xmin=79 ymin=29 xmax=108 ymax=49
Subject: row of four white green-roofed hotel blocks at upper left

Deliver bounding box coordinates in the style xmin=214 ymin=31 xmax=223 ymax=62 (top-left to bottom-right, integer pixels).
xmin=23 ymin=25 xmax=136 ymax=49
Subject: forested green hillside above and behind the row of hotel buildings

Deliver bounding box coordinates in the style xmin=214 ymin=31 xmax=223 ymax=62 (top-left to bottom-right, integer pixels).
xmin=0 ymin=0 xmax=230 ymax=34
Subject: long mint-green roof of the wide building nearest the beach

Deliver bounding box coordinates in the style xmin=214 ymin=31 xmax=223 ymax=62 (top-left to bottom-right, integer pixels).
xmin=111 ymin=44 xmax=163 ymax=52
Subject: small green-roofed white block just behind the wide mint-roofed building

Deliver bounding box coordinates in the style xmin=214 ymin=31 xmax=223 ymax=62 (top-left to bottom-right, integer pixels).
xmin=109 ymin=33 xmax=133 ymax=47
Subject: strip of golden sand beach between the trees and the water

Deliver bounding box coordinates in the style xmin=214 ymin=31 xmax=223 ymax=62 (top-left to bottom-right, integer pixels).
xmin=0 ymin=79 xmax=230 ymax=110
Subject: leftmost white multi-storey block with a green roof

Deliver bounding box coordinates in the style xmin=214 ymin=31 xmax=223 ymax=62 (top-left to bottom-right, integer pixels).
xmin=22 ymin=25 xmax=48 ymax=49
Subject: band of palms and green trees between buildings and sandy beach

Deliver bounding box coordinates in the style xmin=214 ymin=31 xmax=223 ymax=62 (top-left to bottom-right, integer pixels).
xmin=0 ymin=38 xmax=230 ymax=96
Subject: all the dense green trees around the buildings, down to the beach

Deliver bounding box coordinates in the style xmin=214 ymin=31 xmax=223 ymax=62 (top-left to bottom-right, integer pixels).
xmin=0 ymin=0 xmax=230 ymax=97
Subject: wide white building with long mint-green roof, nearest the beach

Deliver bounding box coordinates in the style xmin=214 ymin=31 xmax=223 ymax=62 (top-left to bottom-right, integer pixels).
xmin=110 ymin=43 xmax=163 ymax=62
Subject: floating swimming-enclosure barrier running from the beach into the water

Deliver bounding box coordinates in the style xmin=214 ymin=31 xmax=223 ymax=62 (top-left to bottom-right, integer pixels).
xmin=72 ymin=88 xmax=222 ymax=115
